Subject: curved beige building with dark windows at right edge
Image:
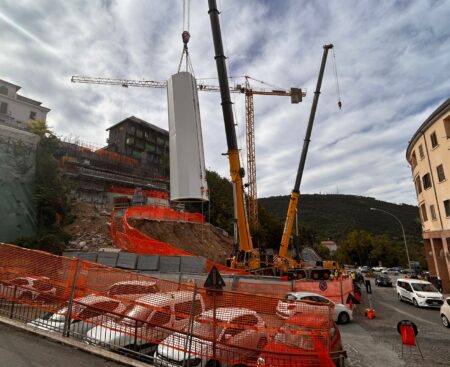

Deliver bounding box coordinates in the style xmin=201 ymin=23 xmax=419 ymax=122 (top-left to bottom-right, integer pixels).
xmin=406 ymin=98 xmax=450 ymax=292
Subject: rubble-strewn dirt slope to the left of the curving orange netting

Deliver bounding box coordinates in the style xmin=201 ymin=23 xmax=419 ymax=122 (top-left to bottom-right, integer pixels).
xmin=63 ymin=202 xmax=113 ymax=251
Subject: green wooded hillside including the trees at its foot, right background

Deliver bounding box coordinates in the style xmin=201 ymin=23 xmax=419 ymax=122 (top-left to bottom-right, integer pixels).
xmin=259 ymin=194 xmax=426 ymax=267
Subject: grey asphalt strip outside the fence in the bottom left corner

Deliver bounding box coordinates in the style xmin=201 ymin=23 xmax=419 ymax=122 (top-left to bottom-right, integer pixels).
xmin=0 ymin=323 xmax=124 ymax=367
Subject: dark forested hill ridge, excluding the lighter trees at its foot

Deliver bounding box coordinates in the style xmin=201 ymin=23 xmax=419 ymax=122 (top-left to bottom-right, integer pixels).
xmin=258 ymin=194 xmax=422 ymax=243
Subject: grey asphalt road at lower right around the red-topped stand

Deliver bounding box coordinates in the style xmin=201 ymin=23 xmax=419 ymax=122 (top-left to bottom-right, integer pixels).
xmin=340 ymin=277 xmax=450 ymax=367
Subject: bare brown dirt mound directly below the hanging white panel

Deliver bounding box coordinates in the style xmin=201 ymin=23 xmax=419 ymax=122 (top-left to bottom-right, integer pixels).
xmin=128 ymin=219 xmax=233 ymax=264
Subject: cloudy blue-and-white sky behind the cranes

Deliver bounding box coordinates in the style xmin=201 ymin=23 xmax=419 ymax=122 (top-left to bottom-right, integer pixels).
xmin=0 ymin=0 xmax=450 ymax=205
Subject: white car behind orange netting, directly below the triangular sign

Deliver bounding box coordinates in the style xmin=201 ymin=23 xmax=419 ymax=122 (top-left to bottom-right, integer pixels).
xmin=153 ymin=307 xmax=267 ymax=367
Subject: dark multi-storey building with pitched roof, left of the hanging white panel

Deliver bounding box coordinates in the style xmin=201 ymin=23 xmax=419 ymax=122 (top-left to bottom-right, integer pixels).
xmin=106 ymin=116 xmax=169 ymax=177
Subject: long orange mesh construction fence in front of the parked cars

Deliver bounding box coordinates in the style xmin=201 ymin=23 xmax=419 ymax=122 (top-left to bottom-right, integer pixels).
xmin=0 ymin=244 xmax=345 ymax=367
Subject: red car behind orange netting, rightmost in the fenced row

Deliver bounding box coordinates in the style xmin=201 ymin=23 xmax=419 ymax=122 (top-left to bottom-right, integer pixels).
xmin=257 ymin=314 xmax=347 ymax=367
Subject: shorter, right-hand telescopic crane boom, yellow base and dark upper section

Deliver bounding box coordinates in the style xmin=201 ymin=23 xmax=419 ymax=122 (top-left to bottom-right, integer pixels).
xmin=278 ymin=44 xmax=333 ymax=268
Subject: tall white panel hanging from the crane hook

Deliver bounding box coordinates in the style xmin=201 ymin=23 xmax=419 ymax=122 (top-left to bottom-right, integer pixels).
xmin=167 ymin=72 xmax=208 ymax=201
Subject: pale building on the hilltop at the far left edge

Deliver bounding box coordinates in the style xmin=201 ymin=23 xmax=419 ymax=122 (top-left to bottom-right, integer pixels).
xmin=0 ymin=79 xmax=50 ymax=130
